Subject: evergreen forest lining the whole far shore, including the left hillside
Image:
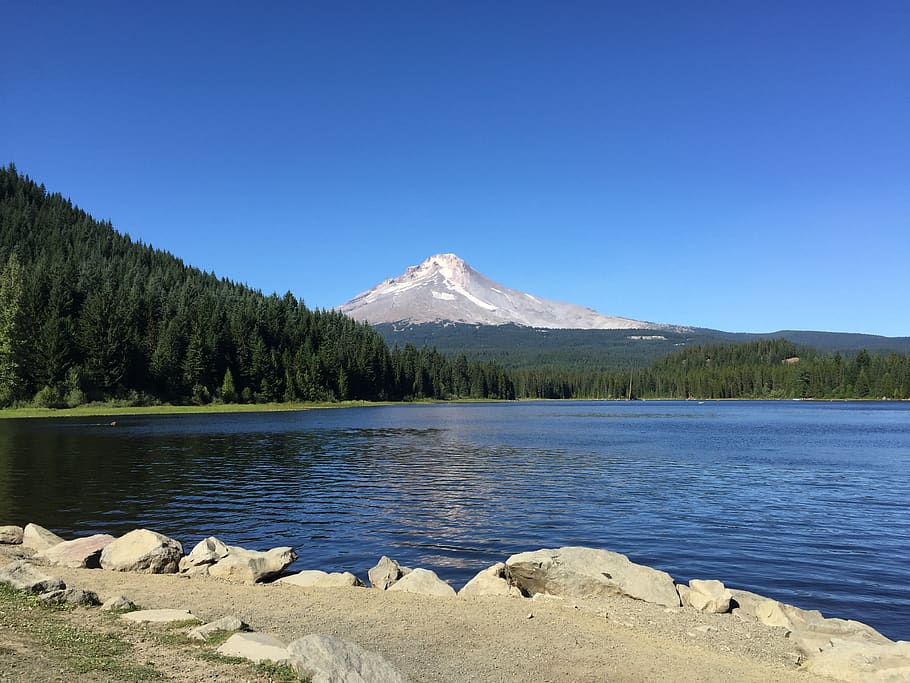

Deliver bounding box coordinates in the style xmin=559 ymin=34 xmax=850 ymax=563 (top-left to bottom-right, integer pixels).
xmin=0 ymin=164 xmax=910 ymax=407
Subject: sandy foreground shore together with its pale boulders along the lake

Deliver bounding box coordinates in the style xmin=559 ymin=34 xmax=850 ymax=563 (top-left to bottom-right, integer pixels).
xmin=0 ymin=524 xmax=910 ymax=682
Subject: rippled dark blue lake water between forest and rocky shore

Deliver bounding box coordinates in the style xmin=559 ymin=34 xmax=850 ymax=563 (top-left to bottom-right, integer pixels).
xmin=0 ymin=401 xmax=910 ymax=640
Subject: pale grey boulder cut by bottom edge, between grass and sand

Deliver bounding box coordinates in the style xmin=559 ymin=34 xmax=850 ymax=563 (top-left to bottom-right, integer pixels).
xmin=287 ymin=634 xmax=408 ymax=683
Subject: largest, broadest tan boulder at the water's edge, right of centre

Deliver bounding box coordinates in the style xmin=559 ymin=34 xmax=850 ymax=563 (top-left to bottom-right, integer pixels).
xmin=506 ymin=546 xmax=680 ymax=607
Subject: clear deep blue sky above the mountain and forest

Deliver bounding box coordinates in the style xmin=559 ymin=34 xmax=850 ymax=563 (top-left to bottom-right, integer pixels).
xmin=0 ymin=0 xmax=910 ymax=336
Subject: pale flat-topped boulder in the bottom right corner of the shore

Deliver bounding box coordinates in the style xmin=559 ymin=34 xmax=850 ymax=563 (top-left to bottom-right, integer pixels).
xmin=802 ymin=639 xmax=910 ymax=683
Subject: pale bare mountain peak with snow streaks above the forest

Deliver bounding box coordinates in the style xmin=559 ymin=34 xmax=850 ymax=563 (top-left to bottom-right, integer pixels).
xmin=338 ymin=254 xmax=670 ymax=330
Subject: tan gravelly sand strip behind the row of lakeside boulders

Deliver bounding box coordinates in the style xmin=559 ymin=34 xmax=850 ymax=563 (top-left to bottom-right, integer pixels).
xmin=0 ymin=554 xmax=840 ymax=683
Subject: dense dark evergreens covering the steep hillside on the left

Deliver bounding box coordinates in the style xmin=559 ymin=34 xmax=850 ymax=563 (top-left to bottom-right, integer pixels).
xmin=0 ymin=164 xmax=514 ymax=407
